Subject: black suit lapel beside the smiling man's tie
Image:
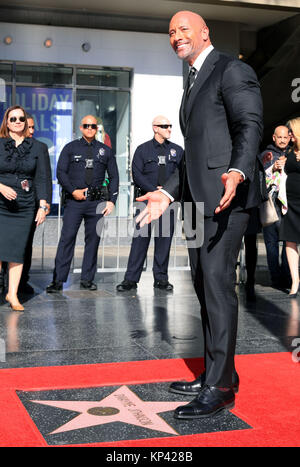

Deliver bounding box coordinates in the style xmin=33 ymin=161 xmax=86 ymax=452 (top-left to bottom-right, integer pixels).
xmin=180 ymin=49 xmax=219 ymax=127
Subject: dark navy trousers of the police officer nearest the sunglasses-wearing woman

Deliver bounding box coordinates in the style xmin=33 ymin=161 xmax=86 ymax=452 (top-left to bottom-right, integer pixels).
xmin=53 ymin=199 xmax=105 ymax=282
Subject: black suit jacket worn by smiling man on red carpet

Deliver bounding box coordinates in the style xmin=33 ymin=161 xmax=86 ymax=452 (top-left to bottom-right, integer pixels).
xmin=164 ymin=49 xmax=263 ymax=216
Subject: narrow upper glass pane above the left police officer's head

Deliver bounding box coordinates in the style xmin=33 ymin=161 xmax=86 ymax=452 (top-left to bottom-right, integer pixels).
xmin=76 ymin=68 xmax=130 ymax=88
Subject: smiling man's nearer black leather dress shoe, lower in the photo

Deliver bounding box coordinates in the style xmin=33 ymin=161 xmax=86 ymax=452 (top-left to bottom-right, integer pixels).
xmin=174 ymin=385 xmax=235 ymax=419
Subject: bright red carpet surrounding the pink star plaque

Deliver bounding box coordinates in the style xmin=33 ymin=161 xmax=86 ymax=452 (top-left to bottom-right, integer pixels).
xmin=0 ymin=353 xmax=300 ymax=447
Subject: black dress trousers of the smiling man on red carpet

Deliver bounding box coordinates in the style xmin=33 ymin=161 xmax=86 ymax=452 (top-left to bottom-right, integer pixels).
xmin=188 ymin=208 xmax=249 ymax=387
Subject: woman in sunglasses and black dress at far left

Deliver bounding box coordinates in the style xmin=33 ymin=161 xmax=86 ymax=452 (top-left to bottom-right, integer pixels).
xmin=0 ymin=106 xmax=47 ymax=311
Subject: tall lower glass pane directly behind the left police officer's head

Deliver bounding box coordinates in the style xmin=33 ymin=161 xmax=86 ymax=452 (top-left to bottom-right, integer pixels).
xmin=74 ymin=89 xmax=130 ymax=216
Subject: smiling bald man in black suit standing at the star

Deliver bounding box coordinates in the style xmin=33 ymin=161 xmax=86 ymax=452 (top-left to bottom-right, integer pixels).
xmin=138 ymin=11 xmax=262 ymax=419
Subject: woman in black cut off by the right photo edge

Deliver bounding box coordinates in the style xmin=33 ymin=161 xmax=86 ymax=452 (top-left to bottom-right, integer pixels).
xmin=279 ymin=117 xmax=300 ymax=298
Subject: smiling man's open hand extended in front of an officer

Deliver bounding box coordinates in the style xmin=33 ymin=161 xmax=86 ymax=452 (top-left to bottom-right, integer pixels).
xmin=136 ymin=190 xmax=171 ymax=227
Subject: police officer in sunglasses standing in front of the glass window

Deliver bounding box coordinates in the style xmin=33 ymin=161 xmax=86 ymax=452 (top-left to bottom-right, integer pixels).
xmin=46 ymin=115 xmax=119 ymax=293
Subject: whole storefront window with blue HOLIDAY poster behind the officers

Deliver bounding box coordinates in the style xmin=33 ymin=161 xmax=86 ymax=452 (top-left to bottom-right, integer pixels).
xmin=0 ymin=61 xmax=132 ymax=217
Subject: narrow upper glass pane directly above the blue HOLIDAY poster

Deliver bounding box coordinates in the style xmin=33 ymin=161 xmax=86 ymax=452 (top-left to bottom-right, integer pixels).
xmin=16 ymin=64 xmax=73 ymax=86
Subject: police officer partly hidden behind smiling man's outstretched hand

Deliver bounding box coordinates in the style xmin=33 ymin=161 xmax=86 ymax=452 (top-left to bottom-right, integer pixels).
xmin=117 ymin=115 xmax=183 ymax=292
